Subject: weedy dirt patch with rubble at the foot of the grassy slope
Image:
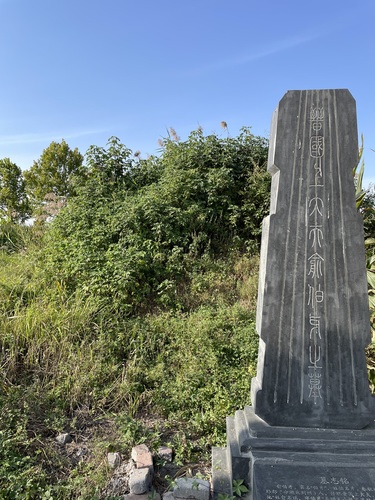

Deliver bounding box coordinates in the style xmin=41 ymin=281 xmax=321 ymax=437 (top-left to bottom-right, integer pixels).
xmin=43 ymin=410 xmax=211 ymax=498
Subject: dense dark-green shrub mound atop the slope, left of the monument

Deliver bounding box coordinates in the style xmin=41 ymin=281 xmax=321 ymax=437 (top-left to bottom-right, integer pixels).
xmin=45 ymin=129 xmax=269 ymax=312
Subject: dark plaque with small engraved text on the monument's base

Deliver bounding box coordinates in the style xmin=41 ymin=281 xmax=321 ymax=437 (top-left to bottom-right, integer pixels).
xmin=253 ymin=456 xmax=375 ymax=500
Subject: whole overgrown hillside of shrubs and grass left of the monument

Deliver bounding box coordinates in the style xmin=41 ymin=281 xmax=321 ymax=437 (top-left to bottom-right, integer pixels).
xmin=0 ymin=129 xmax=270 ymax=498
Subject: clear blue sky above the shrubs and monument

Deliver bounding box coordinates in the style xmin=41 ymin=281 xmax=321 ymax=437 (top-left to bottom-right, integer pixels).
xmin=0 ymin=0 xmax=375 ymax=184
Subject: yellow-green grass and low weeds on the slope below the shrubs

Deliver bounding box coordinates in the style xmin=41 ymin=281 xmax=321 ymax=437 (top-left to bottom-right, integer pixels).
xmin=0 ymin=235 xmax=257 ymax=498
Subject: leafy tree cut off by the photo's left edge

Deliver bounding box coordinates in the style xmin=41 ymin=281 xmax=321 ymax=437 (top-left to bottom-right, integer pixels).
xmin=0 ymin=158 xmax=29 ymax=223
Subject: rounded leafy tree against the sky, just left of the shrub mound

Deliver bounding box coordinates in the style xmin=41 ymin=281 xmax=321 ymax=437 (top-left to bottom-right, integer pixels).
xmin=25 ymin=139 xmax=85 ymax=205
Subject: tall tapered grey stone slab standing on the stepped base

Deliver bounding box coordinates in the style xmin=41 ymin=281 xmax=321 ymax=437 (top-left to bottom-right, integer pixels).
xmin=252 ymin=90 xmax=374 ymax=429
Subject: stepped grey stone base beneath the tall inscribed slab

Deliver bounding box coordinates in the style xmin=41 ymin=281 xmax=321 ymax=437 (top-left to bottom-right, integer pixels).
xmin=212 ymin=407 xmax=375 ymax=500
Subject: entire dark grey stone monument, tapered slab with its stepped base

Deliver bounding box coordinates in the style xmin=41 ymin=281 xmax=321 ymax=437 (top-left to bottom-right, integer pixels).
xmin=213 ymin=90 xmax=375 ymax=500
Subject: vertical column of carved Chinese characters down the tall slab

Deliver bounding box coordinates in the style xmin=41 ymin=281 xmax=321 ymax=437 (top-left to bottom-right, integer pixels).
xmin=305 ymin=103 xmax=326 ymax=404
